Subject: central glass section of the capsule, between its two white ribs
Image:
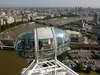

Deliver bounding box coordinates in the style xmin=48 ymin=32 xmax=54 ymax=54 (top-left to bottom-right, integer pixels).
xmin=39 ymin=38 xmax=54 ymax=58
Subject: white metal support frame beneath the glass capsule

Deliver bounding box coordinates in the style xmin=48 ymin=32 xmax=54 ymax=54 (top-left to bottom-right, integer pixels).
xmin=21 ymin=60 xmax=78 ymax=75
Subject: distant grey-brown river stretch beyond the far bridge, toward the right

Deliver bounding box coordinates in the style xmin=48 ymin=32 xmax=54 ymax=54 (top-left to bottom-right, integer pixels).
xmin=39 ymin=17 xmax=93 ymax=26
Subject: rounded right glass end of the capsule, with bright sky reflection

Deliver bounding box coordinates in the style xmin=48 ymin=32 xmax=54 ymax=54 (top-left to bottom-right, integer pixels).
xmin=54 ymin=28 xmax=70 ymax=55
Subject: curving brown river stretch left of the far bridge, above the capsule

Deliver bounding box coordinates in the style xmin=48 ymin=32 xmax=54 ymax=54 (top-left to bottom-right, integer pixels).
xmin=1 ymin=23 xmax=44 ymax=40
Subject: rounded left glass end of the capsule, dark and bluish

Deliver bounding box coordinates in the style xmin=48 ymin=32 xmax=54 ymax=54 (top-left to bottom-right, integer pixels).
xmin=15 ymin=30 xmax=35 ymax=59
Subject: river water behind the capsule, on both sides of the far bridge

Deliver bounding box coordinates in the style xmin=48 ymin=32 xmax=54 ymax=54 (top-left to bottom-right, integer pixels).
xmin=2 ymin=17 xmax=93 ymax=40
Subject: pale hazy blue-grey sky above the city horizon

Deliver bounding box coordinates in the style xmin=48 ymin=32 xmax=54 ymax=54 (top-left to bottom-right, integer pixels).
xmin=0 ymin=0 xmax=100 ymax=8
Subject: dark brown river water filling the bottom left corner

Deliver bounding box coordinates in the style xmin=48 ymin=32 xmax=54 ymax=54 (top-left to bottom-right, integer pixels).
xmin=0 ymin=51 xmax=27 ymax=75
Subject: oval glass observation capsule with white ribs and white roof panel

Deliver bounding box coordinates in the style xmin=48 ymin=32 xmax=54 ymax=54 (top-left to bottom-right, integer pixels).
xmin=14 ymin=27 xmax=70 ymax=59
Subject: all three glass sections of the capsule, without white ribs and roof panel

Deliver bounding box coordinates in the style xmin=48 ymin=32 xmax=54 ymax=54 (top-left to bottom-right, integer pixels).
xmin=15 ymin=28 xmax=70 ymax=59
